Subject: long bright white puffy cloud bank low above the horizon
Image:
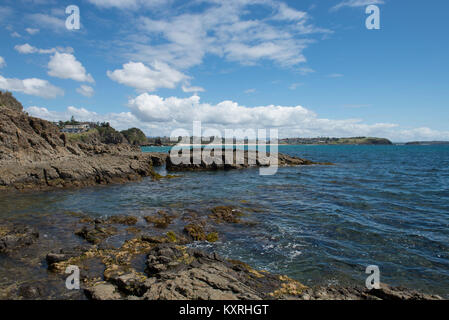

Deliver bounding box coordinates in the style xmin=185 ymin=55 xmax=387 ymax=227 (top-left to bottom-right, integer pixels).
xmin=125 ymin=93 xmax=390 ymax=130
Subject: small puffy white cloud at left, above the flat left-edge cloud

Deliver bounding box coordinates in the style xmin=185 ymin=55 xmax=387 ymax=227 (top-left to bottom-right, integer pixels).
xmin=48 ymin=52 xmax=94 ymax=82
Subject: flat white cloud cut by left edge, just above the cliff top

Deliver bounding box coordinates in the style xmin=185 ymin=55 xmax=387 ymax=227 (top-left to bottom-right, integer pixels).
xmin=0 ymin=76 xmax=64 ymax=98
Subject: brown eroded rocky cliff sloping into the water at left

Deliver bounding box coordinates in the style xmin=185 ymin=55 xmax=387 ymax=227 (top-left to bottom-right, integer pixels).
xmin=0 ymin=105 xmax=153 ymax=190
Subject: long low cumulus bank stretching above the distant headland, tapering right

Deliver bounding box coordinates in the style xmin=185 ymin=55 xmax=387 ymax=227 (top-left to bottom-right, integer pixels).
xmin=122 ymin=93 xmax=395 ymax=136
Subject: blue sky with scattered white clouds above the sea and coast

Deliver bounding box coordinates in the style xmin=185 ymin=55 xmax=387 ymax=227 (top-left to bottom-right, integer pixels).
xmin=0 ymin=0 xmax=449 ymax=141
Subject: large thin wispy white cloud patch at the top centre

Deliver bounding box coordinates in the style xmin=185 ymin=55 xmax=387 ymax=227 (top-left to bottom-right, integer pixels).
xmin=120 ymin=0 xmax=331 ymax=69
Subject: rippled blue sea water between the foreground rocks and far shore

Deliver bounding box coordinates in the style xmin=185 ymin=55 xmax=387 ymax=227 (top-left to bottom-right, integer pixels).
xmin=0 ymin=146 xmax=449 ymax=298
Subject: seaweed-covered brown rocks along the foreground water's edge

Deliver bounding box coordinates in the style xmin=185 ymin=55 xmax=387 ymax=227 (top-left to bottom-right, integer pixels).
xmin=0 ymin=206 xmax=441 ymax=300
